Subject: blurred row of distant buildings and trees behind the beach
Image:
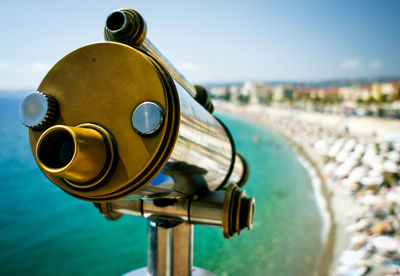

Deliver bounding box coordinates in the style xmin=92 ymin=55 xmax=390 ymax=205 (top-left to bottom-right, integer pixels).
xmin=210 ymin=81 xmax=400 ymax=117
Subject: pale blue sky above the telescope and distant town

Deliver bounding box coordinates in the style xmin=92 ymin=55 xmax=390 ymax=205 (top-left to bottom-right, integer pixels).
xmin=0 ymin=0 xmax=400 ymax=89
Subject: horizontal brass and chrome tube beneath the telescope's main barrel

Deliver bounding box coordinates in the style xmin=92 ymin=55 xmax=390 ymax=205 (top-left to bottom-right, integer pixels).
xmin=95 ymin=184 xmax=255 ymax=239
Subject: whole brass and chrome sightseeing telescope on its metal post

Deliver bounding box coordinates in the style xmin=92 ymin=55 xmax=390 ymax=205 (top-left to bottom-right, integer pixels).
xmin=20 ymin=9 xmax=255 ymax=275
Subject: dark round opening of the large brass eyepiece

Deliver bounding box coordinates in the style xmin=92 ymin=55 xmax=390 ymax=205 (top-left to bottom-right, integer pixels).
xmin=38 ymin=129 xmax=75 ymax=169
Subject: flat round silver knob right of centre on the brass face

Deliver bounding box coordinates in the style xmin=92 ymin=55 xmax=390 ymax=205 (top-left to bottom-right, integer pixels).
xmin=132 ymin=102 xmax=164 ymax=136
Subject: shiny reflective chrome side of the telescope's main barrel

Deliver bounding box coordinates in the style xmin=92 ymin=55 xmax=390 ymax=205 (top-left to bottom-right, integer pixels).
xmin=150 ymin=80 xmax=234 ymax=195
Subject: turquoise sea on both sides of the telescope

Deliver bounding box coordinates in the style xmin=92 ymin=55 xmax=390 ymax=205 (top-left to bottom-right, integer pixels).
xmin=0 ymin=99 xmax=323 ymax=275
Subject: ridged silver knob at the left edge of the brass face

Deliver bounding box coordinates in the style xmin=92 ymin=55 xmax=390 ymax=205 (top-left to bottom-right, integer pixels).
xmin=19 ymin=92 xmax=59 ymax=130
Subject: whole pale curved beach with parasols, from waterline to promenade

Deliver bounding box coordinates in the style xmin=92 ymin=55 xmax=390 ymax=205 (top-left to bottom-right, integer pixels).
xmin=215 ymin=101 xmax=400 ymax=275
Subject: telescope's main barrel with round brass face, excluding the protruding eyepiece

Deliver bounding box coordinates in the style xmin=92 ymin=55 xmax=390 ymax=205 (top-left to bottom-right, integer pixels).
xmin=30 ymin=42 xmax=246 ymax=202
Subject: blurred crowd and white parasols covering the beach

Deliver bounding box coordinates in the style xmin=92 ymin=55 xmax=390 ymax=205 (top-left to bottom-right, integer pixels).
xmin=216 ymin=101 xmax=400 ymax=275
